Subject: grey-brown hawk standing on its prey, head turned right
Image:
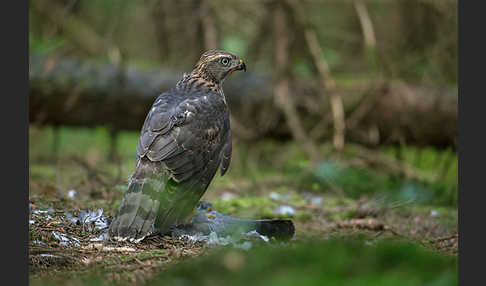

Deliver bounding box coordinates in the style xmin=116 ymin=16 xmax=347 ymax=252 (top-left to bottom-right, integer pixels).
xmin=108 ymin=50 xmax=246 ymax=242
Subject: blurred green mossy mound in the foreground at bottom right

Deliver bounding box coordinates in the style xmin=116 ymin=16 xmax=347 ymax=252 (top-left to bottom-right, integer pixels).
xmin=148 ymin=240 xmax=457 ymax=285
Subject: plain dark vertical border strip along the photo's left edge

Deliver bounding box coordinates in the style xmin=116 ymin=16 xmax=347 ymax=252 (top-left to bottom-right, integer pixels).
xmin=0 ymin=1 xmax=29 ymax=285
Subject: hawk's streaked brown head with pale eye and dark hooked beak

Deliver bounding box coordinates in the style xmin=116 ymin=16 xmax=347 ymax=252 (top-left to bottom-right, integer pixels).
xmin=192 ymin=50 xmax=246 ymax=84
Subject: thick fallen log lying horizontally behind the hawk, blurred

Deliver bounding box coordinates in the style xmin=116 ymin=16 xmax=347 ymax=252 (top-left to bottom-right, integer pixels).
xmin=29 ymin=54 xmax=458 ymax=148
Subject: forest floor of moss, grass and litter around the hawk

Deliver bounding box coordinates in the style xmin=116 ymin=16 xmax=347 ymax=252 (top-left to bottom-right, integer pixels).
xmin=29 ymin=128 xmax=458 ymax=285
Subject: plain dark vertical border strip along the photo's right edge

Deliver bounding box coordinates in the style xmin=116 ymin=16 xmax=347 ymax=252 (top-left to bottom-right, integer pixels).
xmin=457 ymin=0 xmax=486 ymax=285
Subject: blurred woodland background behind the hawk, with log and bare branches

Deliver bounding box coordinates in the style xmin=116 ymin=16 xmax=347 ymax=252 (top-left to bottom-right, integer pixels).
xmin=29 ymin=0 xmax=458 ymax=284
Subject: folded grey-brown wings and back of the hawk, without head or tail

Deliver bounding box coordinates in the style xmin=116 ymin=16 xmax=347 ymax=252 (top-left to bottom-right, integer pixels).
xmin=137 ymin=91 xmax=231 ymax=182
